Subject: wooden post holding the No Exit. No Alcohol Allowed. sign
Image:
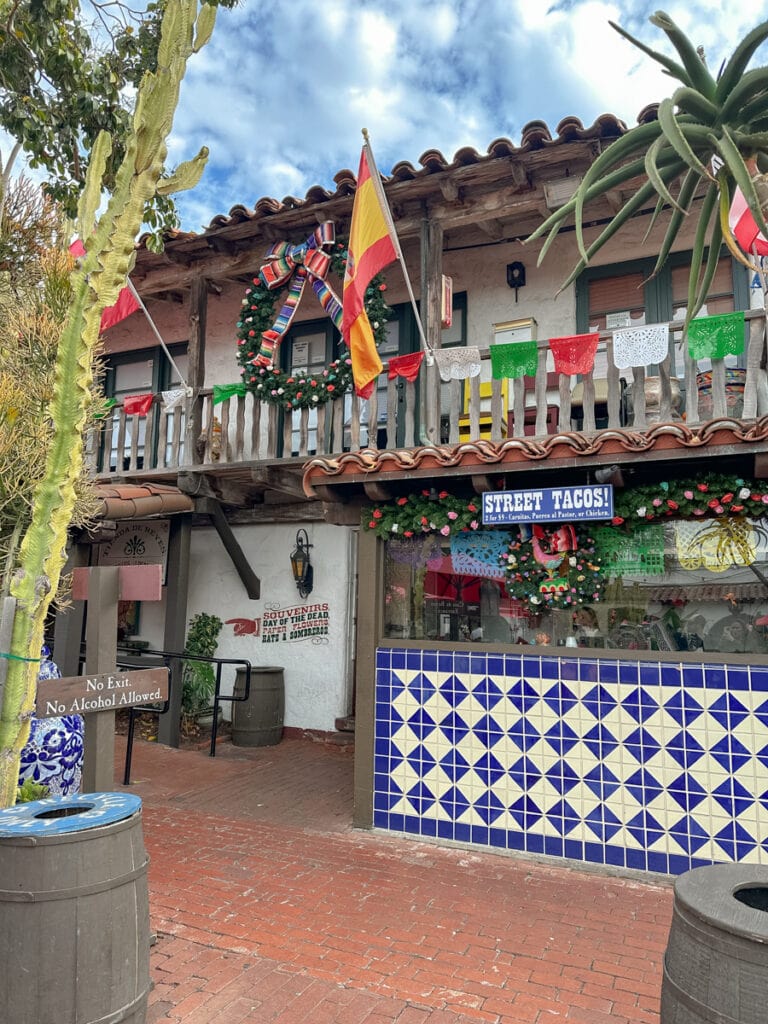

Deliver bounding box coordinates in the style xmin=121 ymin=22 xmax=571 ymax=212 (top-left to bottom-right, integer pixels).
xmin=83 ymin=565 xmax=120 ymax=793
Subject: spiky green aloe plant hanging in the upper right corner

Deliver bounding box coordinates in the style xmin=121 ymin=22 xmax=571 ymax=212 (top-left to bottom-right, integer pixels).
xmin=527 ymin=11 xmax=768 ymax=321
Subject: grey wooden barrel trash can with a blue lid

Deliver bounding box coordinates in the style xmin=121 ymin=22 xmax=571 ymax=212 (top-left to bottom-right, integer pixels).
xmin=0 ymin=793 xmax=150 ymax=1024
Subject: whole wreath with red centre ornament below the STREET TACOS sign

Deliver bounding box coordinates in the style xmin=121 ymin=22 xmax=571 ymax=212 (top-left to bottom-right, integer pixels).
xmin=499 ymin=523 xmax=603 ymax=611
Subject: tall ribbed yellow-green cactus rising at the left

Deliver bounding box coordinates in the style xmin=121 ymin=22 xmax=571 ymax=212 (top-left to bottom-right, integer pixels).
xmin=0 ymin=0 xmax=216 ymax=808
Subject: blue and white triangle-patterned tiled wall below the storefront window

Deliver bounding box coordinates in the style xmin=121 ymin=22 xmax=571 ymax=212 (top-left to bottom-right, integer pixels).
xmin=374 ymin=648 xmax=768 ymax=874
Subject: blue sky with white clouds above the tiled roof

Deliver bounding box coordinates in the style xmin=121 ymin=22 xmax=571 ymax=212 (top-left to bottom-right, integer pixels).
xmin=6 ymin=0 xmax=768 ymax=231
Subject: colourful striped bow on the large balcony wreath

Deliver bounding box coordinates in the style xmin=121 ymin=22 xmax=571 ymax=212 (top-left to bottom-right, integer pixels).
xmin=253 ymin=220 xmax=342 ymax=367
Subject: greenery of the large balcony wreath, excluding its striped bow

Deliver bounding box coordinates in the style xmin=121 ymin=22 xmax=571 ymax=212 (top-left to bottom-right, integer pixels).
xmin=237 ymin=243 xmax=392 ymax=410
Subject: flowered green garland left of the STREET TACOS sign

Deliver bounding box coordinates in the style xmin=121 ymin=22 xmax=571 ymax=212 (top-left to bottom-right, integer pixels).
xmin=361 ymin=490 xmax=480 ymax=541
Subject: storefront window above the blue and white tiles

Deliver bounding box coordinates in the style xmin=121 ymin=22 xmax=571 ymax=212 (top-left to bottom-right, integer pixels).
xmin=384 ymin=515 xmax=768 ymax=653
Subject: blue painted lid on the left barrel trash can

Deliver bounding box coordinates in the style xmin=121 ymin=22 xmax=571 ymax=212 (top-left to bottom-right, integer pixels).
xmin=0 ymin=793 xmax=141 ymax=839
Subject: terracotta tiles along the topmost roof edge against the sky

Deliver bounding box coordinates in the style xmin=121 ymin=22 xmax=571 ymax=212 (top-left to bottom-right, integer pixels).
xmin=134 ymin=110 xmax=658 ymax=249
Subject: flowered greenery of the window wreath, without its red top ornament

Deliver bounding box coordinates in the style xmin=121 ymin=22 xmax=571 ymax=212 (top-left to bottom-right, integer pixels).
xmin=500 ymin=523 xmax=603 ymax=611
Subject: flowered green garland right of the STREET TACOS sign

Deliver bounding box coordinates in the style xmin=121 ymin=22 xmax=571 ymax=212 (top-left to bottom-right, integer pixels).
xmin=613 ymin=475 xmax=768 ymax=526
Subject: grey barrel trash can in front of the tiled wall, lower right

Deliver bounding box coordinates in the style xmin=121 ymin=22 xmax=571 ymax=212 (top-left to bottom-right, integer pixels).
xmin=660 ymin=864 xmax=768 ymax=1024
